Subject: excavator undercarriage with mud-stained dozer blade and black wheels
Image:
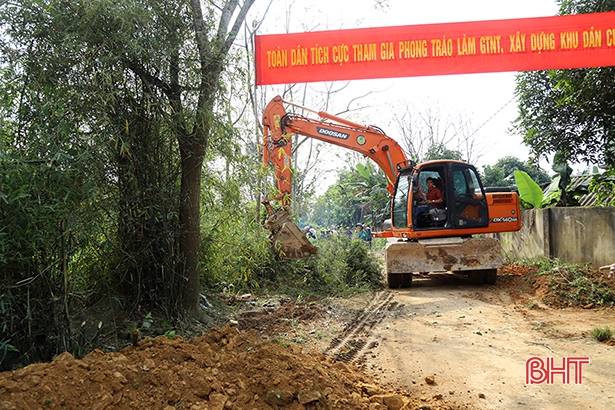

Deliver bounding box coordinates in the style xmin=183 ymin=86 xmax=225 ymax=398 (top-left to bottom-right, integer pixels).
xmin=386 ymin=237 xmax=502 ymax=288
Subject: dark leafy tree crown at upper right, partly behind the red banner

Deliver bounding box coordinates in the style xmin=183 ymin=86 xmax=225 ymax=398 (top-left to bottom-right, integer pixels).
xmin=515 ymin=0 xmax=615 ymax=167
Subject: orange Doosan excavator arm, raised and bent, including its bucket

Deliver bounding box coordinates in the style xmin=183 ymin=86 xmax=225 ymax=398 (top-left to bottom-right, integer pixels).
xmin=262 ymin=96 xmax=412 ymax=258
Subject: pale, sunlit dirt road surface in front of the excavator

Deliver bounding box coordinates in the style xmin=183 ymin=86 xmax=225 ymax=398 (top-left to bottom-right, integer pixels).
xmin=306 ymin=275 xmax=615 ymax=409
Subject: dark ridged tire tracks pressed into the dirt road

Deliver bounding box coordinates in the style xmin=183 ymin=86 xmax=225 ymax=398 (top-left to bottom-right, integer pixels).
xmin=324 ymin=291 xmax=397 ymax=365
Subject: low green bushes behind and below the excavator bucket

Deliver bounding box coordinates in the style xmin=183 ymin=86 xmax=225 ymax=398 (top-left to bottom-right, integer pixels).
xmin=201 ymin=210 xmax=383 ymax=296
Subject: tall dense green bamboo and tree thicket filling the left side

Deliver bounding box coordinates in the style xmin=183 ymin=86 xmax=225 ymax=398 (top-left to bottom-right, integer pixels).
xmin=0 ymin=0 xmax=258 ymax=362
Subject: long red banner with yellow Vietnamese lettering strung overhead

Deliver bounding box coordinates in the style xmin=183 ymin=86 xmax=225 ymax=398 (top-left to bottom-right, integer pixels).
xmin=255 ymin=12 xmax=615 ymax=85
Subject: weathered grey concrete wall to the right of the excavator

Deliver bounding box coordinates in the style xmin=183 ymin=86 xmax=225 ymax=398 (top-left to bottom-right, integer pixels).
xmin=501 ymin=207 xmax=615 ymax=268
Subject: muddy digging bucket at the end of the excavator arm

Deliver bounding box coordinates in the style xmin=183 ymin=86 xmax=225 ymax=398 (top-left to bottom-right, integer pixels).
xmin=265 ymin=208 xmax=318 ymax=259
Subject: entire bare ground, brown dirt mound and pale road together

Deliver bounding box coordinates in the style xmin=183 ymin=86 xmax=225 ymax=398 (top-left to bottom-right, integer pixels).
xmin=0 ymin=266 xmax=615 ymax=410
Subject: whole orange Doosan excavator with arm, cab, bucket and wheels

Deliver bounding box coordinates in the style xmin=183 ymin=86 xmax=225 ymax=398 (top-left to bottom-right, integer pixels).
xmin=262 ymin=96 xmax=521 ymax=288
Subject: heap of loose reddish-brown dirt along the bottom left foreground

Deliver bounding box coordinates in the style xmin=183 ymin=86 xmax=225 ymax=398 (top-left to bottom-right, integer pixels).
xmin=0 ymin=326 xmax=465 ymax=410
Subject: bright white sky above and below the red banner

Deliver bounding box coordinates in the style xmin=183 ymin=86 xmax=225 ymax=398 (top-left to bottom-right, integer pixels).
xmin=253 ymin=0 xmax=559 ymax=186
